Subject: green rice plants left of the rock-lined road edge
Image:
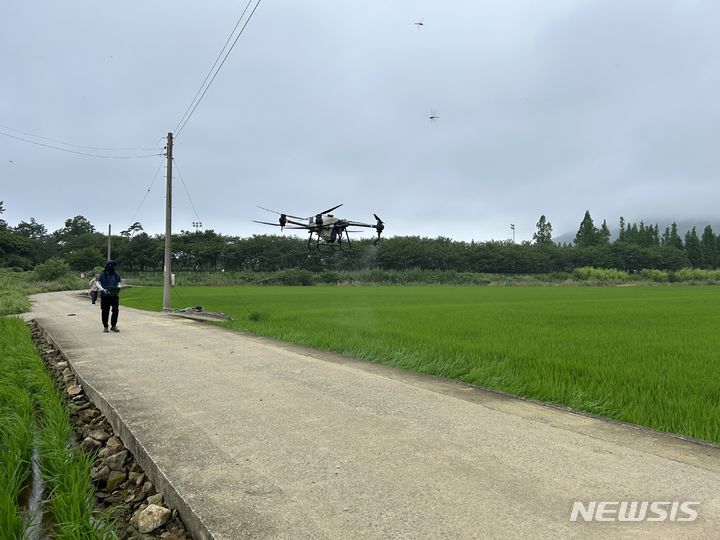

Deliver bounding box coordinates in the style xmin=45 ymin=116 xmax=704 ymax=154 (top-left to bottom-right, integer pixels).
xmin=0 ymin=317 xmax=116 ymax=540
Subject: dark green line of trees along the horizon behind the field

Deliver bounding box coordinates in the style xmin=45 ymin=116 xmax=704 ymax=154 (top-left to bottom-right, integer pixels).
xmin=0 ymin=205 xmax=720 ymax=274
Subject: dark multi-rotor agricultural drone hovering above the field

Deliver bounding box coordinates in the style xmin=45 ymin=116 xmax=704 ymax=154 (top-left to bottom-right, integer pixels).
xmin=253 ymin=204 xmax=385 ymax=251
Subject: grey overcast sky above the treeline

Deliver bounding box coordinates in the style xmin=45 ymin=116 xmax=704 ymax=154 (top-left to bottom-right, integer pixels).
xmin=0 ymin=0 xmax=720 ymax=241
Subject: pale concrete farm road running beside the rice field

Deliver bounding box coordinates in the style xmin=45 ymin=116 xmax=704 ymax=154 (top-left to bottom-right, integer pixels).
xmin=26 ymin=293 xmax=720 ymax=539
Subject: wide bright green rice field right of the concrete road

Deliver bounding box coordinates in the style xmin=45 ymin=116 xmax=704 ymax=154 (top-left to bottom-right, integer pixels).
xmin=121 ymin=285 xmax=720 ymax=442
